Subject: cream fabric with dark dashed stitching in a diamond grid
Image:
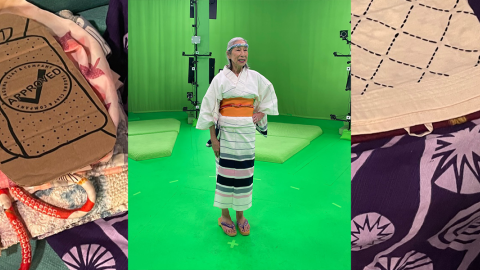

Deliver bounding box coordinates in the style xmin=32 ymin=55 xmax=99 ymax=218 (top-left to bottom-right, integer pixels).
xmin=351 ymin=0 xmax=480 ymax=135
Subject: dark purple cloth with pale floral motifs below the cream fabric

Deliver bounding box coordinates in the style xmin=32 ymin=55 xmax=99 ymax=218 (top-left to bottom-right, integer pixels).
xmin=351 ymin=120 xmax=480 ymax=270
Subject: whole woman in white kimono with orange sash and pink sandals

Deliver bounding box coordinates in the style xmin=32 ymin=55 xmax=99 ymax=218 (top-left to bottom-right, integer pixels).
xmin=197 ymin=38 xmax=278 ymax=236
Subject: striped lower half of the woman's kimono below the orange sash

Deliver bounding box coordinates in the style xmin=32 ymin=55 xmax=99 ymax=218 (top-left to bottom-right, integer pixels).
xmin=213 ymin=126 xmax=255 ymax=211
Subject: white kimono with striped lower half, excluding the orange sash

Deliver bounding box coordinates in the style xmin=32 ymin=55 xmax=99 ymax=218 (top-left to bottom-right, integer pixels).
xmin=197 ymin=67 xmax=278 ymax=211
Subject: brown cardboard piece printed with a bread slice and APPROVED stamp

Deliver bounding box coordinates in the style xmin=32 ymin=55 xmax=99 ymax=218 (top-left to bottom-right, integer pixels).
xmin=0 ymin=14 xmax=116 ymax=186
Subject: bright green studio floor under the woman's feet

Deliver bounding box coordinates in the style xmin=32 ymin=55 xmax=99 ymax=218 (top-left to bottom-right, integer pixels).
xmin=129 ymin=112 xmax=350 ymax=270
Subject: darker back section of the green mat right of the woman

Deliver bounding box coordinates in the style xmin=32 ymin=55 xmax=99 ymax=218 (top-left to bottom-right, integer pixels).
xmin=258 ymin=122 xmax=323 ymax=141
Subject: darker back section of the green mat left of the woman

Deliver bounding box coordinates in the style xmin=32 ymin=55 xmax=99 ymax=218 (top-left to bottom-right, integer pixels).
xmin=128 ymin=118 xmax=180 ymax=137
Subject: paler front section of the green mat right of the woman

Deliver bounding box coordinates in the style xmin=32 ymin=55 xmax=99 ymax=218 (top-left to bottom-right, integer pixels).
xmin=255 ymin=135 xmax=310 ymax=163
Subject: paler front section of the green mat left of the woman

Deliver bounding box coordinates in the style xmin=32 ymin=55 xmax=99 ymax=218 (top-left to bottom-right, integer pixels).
xmin=128 ymin=132 xmax=180 ymax=161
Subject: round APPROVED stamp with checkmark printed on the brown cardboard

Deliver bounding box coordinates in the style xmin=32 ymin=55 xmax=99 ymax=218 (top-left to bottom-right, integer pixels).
xmin=0 ymin=62 xmax=72 ymax=113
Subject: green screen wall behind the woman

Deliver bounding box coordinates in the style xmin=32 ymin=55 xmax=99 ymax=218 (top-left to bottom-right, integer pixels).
xmin=129 ymin=0 xmax=350 ymax=119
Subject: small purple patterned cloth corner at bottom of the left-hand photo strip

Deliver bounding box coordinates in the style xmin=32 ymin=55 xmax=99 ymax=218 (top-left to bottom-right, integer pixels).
xmin=46 ymin=213 xmax=128 ymax=270
